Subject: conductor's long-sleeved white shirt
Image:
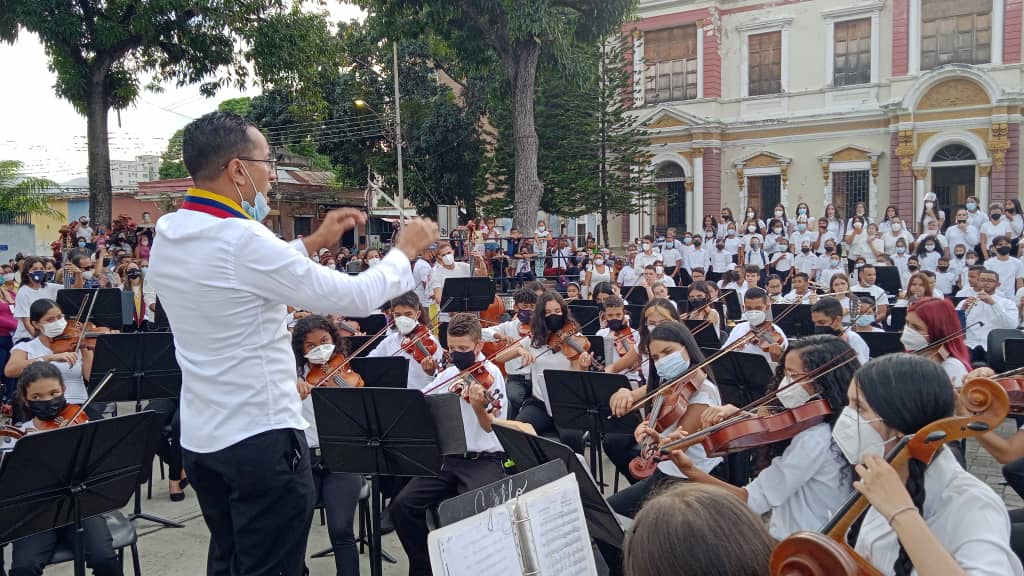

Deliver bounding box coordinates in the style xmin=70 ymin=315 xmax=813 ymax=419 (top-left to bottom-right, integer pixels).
xmin=146 ymin=203 xmax=413 ymax=453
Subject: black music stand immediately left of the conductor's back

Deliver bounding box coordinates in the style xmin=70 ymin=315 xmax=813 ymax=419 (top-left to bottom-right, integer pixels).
xmin=89 ymin=332 xmax=184 ymax=528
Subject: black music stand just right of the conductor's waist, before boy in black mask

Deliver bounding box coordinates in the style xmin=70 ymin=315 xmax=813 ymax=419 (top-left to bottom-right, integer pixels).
xmin=312 ymin=383 xmax=464 ymax=576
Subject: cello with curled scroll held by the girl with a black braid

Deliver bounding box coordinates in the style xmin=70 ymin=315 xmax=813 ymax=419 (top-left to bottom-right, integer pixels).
xmin=769 ymin=378 xmax=1010 ymax=576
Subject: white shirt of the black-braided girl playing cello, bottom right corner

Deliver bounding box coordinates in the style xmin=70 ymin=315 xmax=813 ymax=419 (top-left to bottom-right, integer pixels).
xmin=855 ymin=449 xmax=1024 ymax=576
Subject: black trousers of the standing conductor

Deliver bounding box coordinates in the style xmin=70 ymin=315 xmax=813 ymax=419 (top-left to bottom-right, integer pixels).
xmin=183 ymin=428 xmax=315 ymax=576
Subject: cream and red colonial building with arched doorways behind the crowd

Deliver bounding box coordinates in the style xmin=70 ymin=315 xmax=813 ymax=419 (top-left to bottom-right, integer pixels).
xmin=621 ymin=0 xmax=1024 ymax=236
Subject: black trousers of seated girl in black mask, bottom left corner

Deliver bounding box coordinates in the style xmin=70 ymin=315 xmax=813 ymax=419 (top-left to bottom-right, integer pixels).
xmin=10 ymin=516 xmax=122 ymax=576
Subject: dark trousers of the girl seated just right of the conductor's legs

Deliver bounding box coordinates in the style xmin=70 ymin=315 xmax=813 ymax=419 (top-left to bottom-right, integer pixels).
xmin=313 ymin=458 xmax=364 ymax=576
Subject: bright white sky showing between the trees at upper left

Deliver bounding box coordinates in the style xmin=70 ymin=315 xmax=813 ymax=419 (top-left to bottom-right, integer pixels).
xmin=0 ymin=1 xmax=361 ymax=182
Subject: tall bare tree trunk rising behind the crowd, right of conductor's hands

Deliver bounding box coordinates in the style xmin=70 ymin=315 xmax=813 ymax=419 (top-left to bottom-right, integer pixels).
xmin=509 ymin=39 xmax=544 ymax=237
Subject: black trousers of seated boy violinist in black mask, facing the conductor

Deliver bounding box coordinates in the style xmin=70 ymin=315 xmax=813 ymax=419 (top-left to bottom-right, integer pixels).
xmin=390 ymin=453 xmax=505 ymax=576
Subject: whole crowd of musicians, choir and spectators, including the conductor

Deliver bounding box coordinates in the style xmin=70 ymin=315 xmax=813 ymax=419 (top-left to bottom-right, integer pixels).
xmin=0 ymin=107 xmax=1024 ymax=576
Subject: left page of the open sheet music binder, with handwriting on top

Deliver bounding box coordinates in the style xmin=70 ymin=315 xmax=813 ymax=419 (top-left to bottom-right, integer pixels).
xmin=427 ymin=500 xmax=522 ymax=576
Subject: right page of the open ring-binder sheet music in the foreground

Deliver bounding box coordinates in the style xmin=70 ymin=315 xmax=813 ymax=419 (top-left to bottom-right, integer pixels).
xmin=520 ymin=475 xmax=597 ymax=576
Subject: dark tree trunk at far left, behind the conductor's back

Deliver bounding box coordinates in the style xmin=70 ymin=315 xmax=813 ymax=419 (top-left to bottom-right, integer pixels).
xmin=85 ymin=66 xmax=113 ymax=230
